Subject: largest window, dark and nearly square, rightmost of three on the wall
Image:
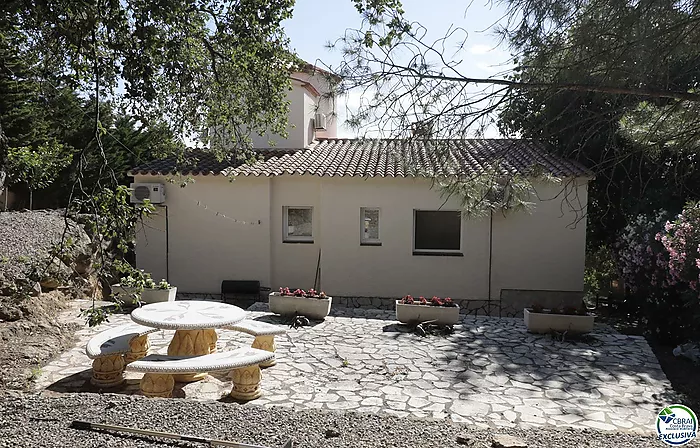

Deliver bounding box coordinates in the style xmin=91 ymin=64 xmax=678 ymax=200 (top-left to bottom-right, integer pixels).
xmin=413 ymin=210 xmax=462 ymax=255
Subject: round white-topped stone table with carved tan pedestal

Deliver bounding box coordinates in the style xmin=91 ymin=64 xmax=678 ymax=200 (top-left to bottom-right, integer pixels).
xmin=131 ymin=300 xmax=246 ymax=382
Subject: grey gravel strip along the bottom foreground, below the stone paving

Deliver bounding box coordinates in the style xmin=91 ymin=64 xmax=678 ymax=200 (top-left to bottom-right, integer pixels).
xmin=0 ymin=393 xmax=688 ymax=448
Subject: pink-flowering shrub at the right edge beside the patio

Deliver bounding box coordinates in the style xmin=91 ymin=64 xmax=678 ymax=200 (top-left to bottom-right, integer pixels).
xmin=617 ymin=204 xmax=700 ymax=343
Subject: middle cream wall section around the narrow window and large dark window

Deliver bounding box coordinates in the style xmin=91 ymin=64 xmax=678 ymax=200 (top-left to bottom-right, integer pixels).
xmin=320 ymin=177 xmax=488 ymax=297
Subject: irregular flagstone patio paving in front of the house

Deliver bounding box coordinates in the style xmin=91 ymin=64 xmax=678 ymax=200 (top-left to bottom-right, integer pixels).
xmin=35 ymin=304 xmax=673 ymax=433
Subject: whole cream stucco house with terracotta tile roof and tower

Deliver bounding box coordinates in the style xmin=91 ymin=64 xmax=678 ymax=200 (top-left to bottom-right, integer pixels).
xmin=131 ymin=65 xmax=590 ymax=314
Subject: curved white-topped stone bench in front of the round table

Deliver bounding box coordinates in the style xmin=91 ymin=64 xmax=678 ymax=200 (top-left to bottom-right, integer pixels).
xmin=126 ymin=347 xmax=274 ymax=401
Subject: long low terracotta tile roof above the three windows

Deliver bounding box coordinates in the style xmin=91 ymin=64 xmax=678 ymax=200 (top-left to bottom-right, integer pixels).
xmin=132 ymin=138 xmax=591 ymax=177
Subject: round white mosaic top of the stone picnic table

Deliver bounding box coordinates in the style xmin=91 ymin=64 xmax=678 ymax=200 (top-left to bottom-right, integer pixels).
xmin=131 ymin=300 xmax=246 ymax=330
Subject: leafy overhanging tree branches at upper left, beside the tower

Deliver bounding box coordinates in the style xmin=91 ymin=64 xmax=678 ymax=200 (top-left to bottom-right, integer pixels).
xmin=10 ymin=0 xmax=298 ymax=153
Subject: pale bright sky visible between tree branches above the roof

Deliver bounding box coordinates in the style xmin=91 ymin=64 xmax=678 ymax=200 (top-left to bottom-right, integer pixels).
xmin=284 ymin=0 xmax=508 ymax=137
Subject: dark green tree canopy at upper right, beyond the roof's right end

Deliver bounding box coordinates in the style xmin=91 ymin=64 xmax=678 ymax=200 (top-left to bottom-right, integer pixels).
xmin=499 ymin=0 xmax=700 ymax=248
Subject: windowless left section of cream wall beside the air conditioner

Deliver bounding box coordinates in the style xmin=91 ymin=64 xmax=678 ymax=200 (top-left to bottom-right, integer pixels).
xmin=136 ymin=176 xmax=270 ymax=293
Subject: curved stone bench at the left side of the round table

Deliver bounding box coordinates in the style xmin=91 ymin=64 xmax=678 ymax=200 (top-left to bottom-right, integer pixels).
xmin=85 ymin=323 xmax=158 ymax=387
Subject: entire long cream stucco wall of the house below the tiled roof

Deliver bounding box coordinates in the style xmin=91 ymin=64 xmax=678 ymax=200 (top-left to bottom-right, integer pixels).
xmin=131 ymin=176 xmax=586 ymax=298
